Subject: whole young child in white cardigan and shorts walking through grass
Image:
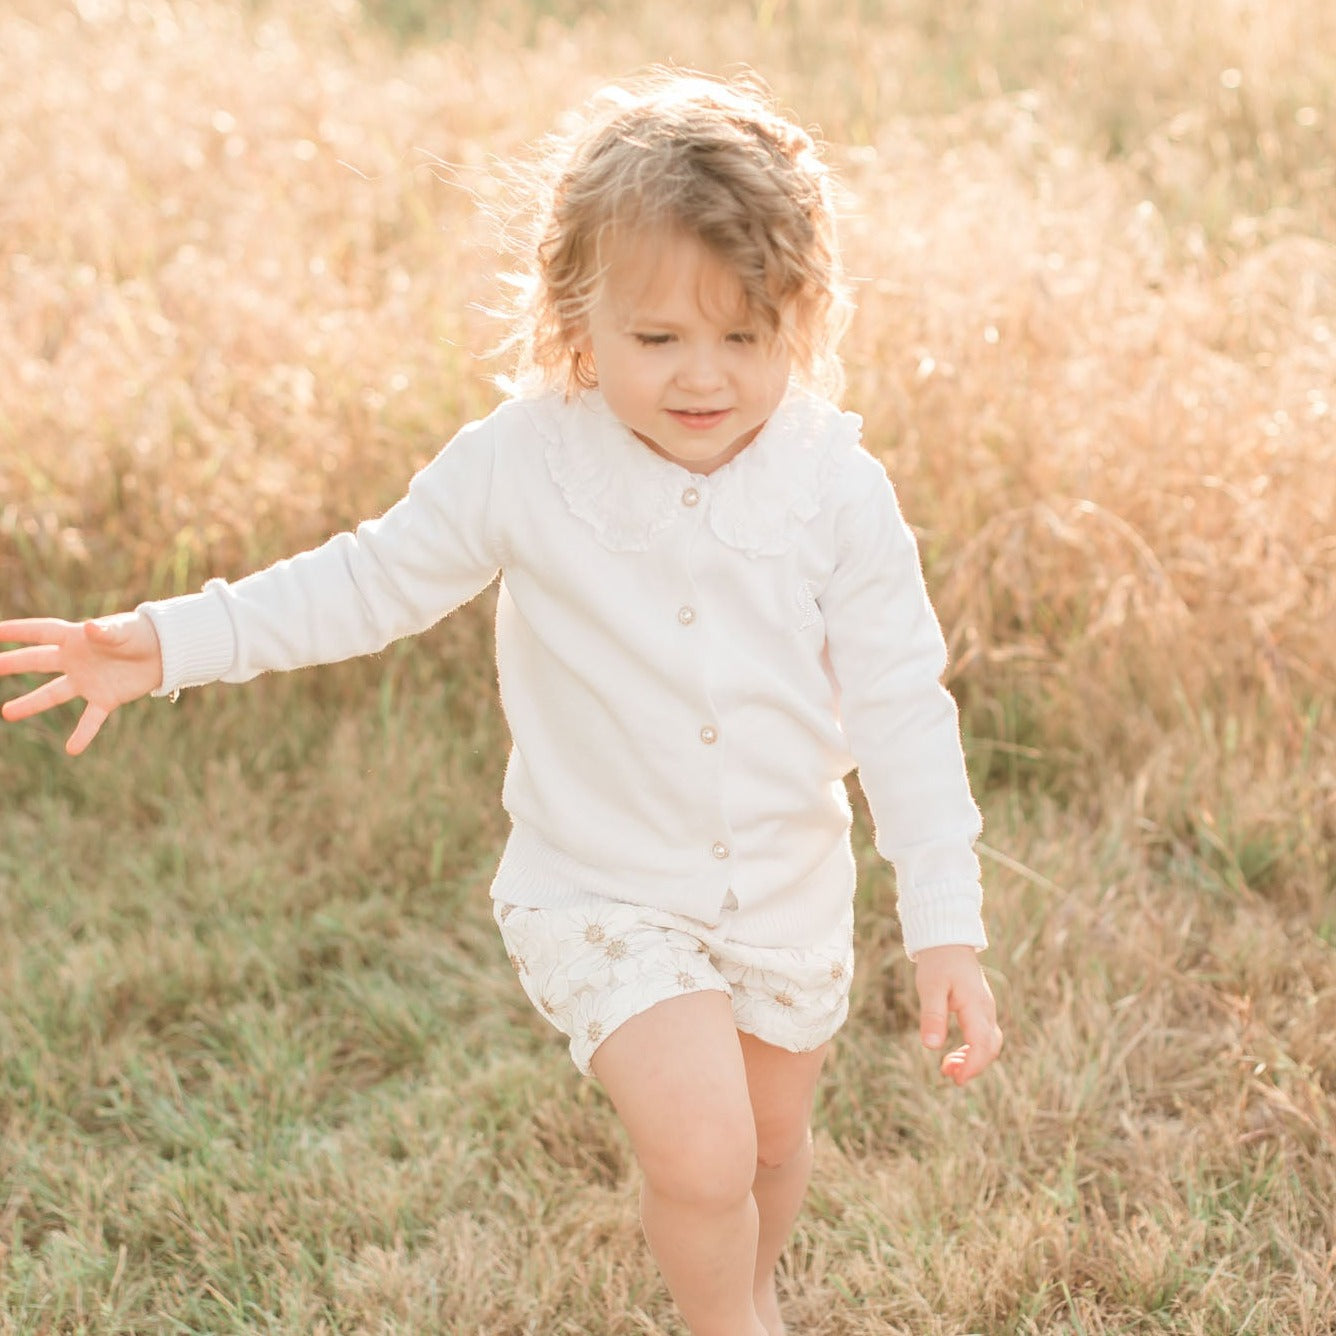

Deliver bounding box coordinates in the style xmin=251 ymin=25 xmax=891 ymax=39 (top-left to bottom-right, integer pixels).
xmin=0 ymin=72 xmax=1002 ymax=1336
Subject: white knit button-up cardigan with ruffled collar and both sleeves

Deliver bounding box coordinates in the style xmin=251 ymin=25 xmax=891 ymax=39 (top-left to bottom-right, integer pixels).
xmin=144 ymin=387 xmax=985 ymax=955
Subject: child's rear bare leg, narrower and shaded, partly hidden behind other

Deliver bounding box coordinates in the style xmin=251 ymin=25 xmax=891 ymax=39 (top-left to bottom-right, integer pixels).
xmin=739 ymin=1034 xmax=828 ymax=1336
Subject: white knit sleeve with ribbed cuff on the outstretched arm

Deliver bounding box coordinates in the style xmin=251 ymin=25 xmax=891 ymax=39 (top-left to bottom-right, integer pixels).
xmin=142 ymin=414 xmax=500 ymax=695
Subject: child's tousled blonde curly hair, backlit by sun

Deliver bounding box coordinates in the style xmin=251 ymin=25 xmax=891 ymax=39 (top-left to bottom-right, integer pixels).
xmin=506 ymin=68 xmax=850 ymax=395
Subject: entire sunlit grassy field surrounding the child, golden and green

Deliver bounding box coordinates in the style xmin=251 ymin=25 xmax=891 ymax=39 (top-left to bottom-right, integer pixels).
xmin=0 ymin=0 xmax=1336 ymax=1336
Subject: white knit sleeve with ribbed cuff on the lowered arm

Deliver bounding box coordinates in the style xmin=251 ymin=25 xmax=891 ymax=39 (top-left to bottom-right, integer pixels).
xmin=819 ymin=454 xmax=987 ymax=957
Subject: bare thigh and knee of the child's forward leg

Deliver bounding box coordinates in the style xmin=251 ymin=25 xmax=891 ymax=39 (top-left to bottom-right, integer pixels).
xmin=592 ymin=991 xmax=756 ymax=1196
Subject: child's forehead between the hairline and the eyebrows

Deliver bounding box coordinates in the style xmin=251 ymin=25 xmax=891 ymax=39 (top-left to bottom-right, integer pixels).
xmin=603 ymin=230 xmax=749 ymax=322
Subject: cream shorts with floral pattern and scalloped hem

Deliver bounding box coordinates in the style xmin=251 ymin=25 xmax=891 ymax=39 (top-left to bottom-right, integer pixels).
xmin=493 ymin=895 xmax=854 ymax=1075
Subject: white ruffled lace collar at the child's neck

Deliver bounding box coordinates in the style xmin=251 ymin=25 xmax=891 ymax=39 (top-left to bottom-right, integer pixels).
xmin=530 ymin=386 xmax=863 ymax=556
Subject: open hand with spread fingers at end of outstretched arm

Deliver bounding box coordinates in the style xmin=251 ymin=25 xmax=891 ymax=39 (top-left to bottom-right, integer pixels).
xmin=0 ymin=612 xmax=163 ymax=756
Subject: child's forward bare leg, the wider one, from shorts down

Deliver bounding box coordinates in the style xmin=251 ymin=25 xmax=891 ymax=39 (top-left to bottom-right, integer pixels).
xmin=592 ymin=993 xmax=768 ymax=1336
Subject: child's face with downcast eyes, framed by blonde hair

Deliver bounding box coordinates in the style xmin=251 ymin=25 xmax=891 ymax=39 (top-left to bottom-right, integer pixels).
xmin=581 ymin=232 xmax=788 ymax=473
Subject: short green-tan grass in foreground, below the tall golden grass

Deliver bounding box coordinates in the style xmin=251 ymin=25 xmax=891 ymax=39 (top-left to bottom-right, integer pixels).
xmin=0 ymin=641 xmax=1336 ymax=1333
